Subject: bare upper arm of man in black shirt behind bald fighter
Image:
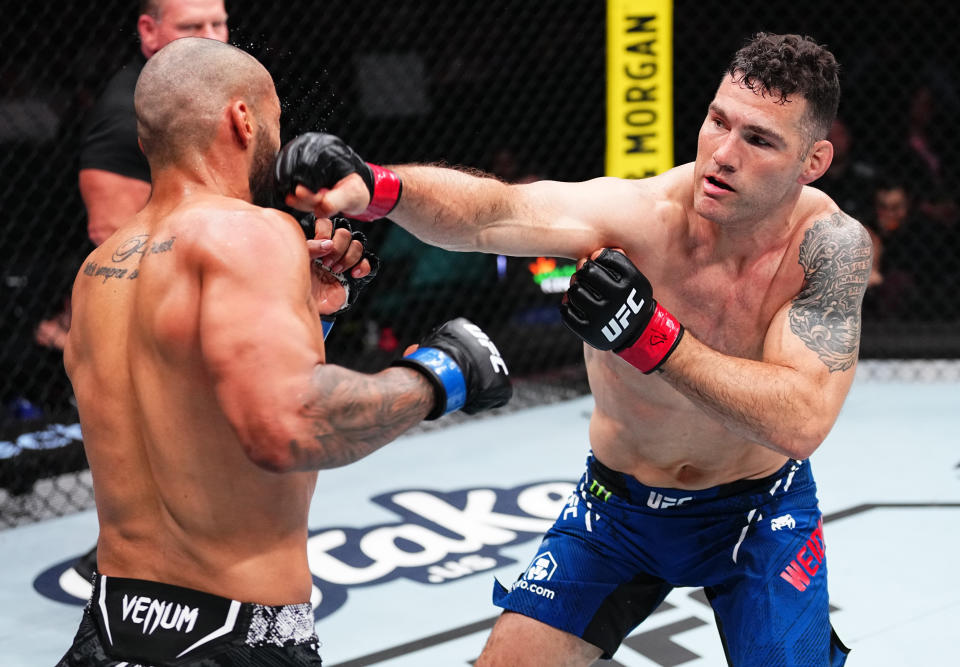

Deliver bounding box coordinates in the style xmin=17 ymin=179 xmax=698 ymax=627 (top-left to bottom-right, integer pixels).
xmin=79 ymin=169 xmax=150 ymax=245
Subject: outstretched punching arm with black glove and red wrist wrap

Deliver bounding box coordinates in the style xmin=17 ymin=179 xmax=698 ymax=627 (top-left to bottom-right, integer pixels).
xmin=276 ymin=133 xmax=644 ymax=258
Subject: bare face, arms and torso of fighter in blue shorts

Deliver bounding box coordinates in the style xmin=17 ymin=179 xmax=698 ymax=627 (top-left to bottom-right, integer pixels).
xmin=378 ymin=77 xmax=871 ymax=489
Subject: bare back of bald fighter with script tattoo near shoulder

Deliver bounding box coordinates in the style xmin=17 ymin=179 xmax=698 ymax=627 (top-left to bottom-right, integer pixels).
xmin=66 ymin=196 xmax=323 ymax=604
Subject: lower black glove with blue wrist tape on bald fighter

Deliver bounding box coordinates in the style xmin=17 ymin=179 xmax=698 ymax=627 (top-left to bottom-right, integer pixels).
xmin=392 ymin=317 xmax=513 ymax=419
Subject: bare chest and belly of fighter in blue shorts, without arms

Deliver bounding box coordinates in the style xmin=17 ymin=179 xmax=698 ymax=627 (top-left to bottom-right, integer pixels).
xmin=584 ymin=164 xmax=838 ymax=489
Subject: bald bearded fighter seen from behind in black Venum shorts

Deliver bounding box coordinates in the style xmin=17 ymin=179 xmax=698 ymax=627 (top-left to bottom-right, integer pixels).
xmin=60 ymin=38 xmax=511 ymax=666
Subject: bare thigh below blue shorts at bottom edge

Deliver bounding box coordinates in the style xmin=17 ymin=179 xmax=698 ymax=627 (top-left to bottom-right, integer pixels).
xmin=475 ymin=611 xmax=601 ymax=667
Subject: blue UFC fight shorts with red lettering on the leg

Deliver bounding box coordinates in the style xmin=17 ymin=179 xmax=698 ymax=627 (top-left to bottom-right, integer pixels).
xmin=493 ymin=456 xmax=849 ymax=667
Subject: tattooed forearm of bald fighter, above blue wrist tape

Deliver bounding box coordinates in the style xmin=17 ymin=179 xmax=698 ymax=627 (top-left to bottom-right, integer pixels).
xmin=290 ymin=365 xmax=434 ymax=468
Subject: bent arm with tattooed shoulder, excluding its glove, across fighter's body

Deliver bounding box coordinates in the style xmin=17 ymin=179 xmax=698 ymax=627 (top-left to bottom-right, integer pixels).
xmin=663 ymin=213 xmax=871 ymax=459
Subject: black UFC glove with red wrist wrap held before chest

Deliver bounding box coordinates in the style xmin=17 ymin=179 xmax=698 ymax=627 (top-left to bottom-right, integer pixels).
xmin=560 ymin=248 xmax=683 ymax=373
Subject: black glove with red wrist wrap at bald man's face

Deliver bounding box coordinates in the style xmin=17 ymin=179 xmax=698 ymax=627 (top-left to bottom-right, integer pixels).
xmin=274 ymin=132 xmax=403 ymax=222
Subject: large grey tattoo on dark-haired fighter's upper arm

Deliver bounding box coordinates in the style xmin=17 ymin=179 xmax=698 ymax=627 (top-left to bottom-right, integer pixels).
xmin=789 ymin=213 xmax=872 ymax=373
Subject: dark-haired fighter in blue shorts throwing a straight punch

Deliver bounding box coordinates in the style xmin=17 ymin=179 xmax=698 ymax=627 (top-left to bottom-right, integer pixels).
xmin=277 ymin=33 xmax=871 ymax=667
